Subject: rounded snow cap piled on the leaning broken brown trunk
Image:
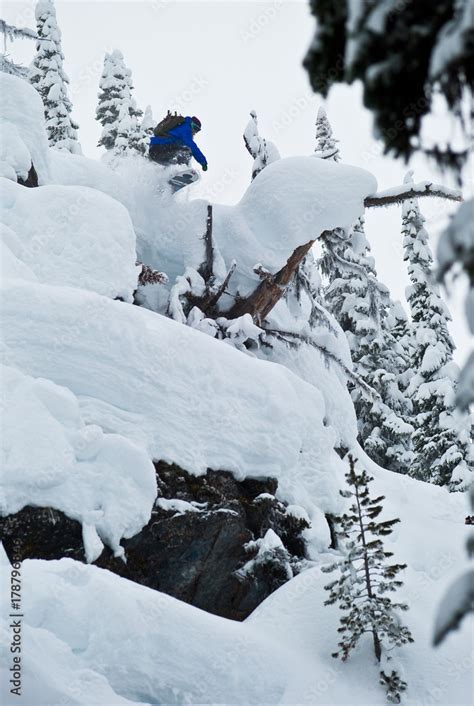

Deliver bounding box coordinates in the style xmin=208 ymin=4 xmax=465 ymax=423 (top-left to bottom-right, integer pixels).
xmin=214 ymin=157 xmax=377 ymax=290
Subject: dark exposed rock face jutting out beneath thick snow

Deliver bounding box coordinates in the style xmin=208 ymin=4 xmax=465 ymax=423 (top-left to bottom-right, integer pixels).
xmin=0 ymin=462 xmax=307 ymax=620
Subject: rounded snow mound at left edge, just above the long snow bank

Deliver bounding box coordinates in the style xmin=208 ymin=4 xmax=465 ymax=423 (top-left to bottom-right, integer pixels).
xmin=0 ymin=179 xmax=138 ymax=301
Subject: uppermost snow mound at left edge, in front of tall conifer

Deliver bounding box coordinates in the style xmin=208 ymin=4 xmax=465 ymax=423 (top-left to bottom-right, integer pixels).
xmin=0 ymin=72 xmax=50 ymax=184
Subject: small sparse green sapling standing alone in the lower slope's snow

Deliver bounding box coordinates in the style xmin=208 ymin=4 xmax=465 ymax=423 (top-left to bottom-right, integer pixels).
xmin=322 ymin=456 xmax=413 ymax=703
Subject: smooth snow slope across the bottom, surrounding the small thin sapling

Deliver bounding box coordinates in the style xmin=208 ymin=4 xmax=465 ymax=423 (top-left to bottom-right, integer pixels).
xmin=3 ymin=466 xmax=472 ymax=706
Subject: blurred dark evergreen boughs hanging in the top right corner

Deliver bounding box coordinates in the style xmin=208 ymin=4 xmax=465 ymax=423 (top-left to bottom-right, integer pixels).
xmin=304 ymin=0 xmax=474 ymax=170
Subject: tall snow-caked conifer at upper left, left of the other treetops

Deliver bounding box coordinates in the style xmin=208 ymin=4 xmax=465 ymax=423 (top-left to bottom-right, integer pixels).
xmin=28 ymin=0 xmax=81 ymax=154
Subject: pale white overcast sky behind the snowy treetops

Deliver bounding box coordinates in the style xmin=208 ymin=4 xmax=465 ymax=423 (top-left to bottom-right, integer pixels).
xmin=1 ymin=0 xmax=471 ymax=362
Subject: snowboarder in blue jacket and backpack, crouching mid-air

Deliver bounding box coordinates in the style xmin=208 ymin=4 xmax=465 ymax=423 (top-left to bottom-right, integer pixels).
xmin=149 ymin=112 xmax=207 ymax=172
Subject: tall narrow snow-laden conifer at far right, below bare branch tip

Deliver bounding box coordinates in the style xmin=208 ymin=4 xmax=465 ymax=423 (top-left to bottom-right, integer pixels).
xmin=402 ymin=171 xmax=473 ymax=490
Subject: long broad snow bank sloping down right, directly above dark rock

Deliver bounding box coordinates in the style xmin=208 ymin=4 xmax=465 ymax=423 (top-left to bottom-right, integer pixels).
xmin=2 ymin=280 xmax=348 ymax=546
